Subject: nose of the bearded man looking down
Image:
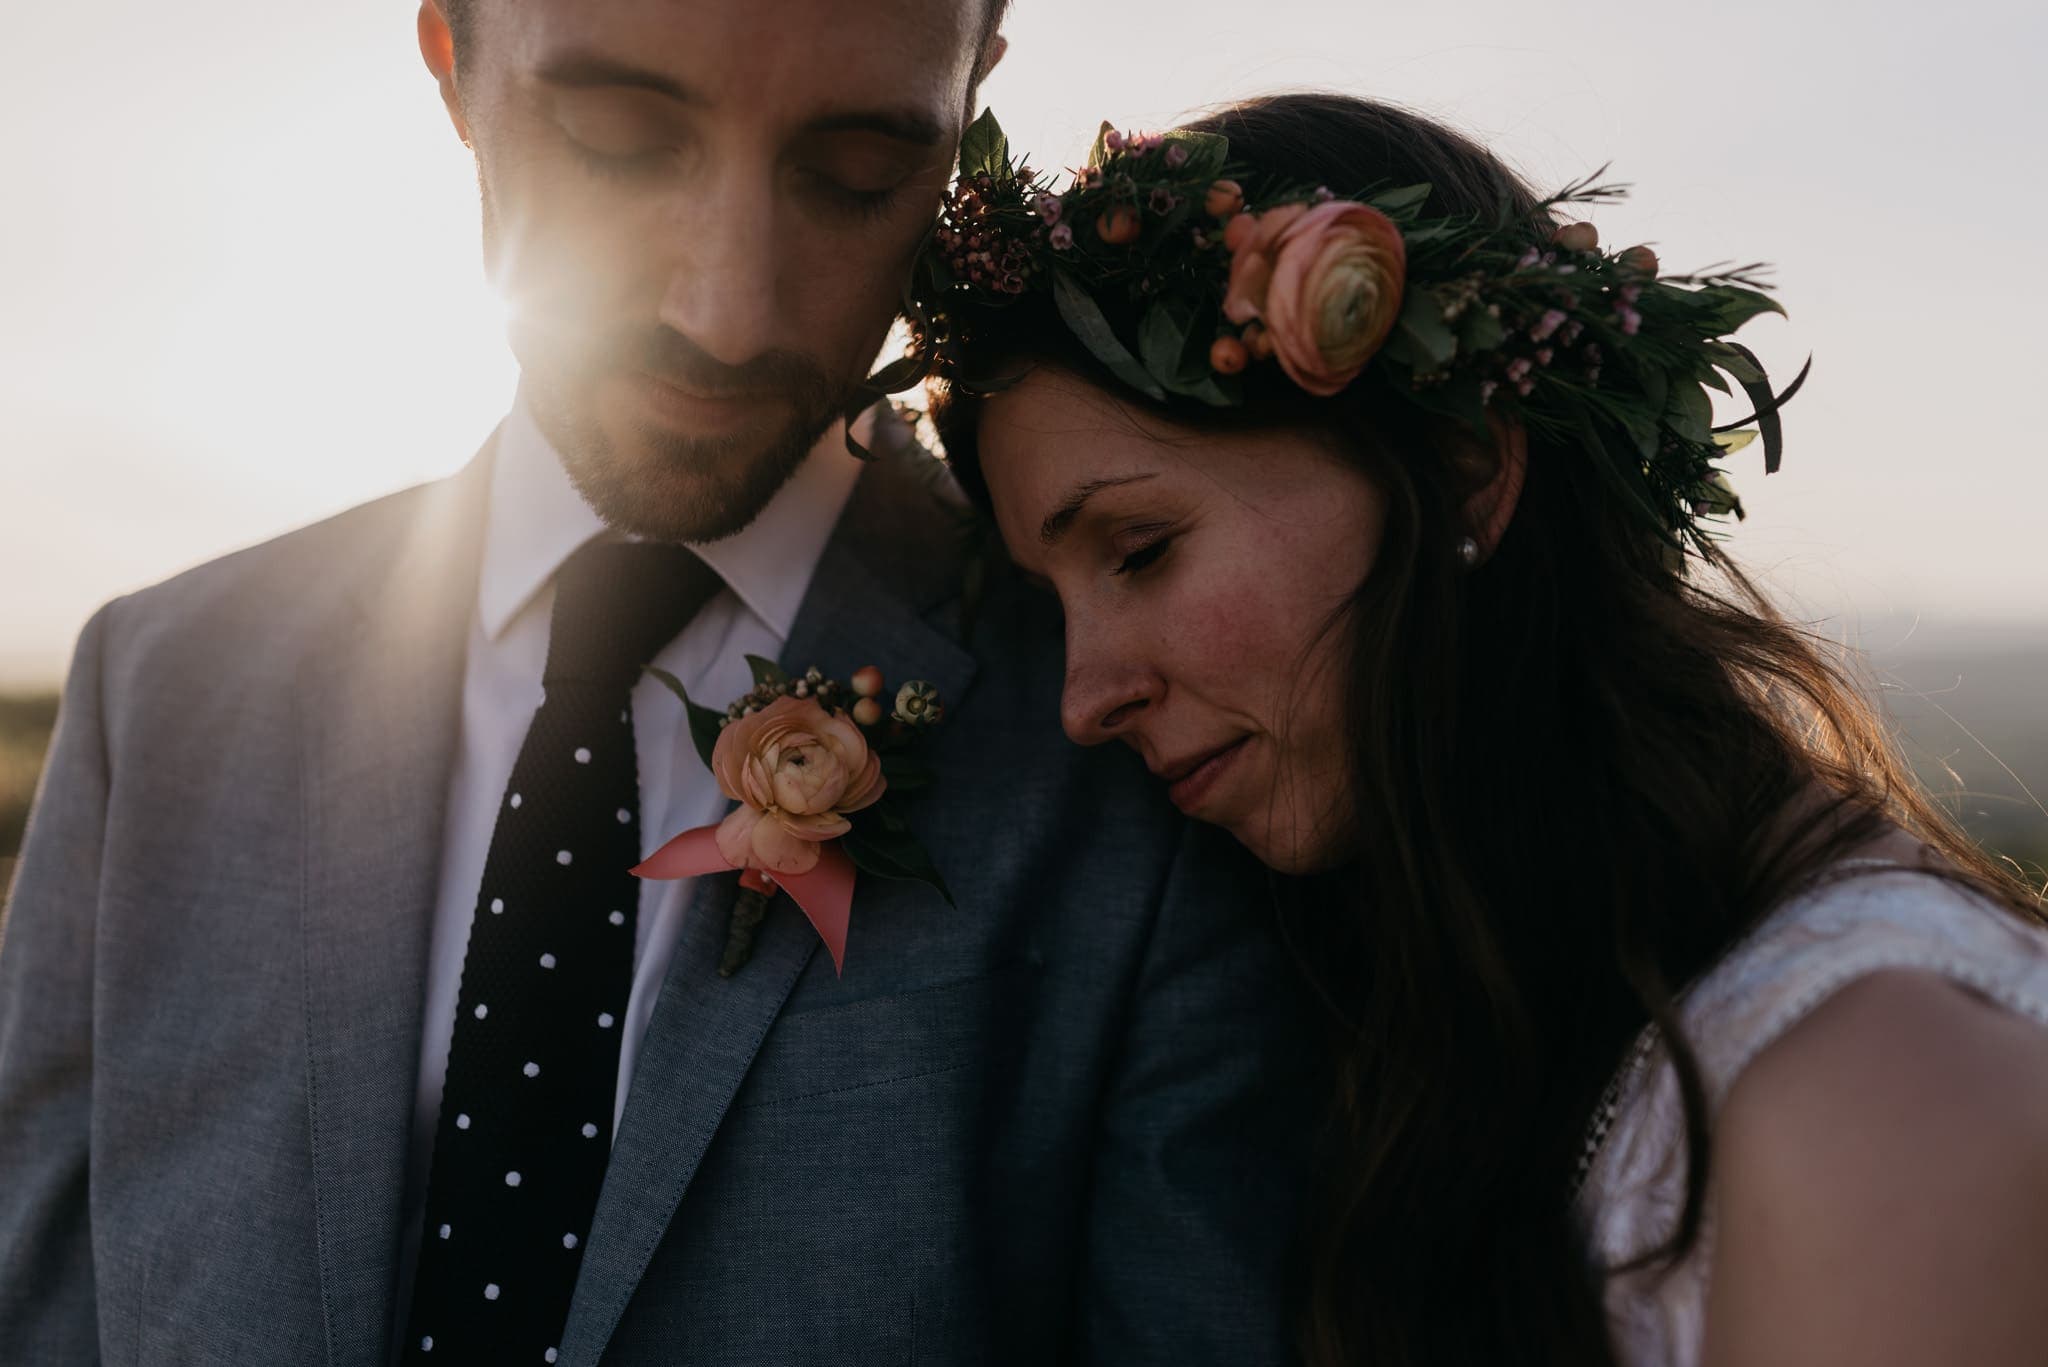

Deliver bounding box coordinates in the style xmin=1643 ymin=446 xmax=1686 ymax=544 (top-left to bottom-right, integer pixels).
xmin=662 ymin=170 xmax=780 ymax=367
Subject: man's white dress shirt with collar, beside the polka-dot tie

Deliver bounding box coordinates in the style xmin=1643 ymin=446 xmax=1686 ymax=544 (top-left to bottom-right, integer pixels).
xmin=397 ymin=402 xmax=860 ymax=1324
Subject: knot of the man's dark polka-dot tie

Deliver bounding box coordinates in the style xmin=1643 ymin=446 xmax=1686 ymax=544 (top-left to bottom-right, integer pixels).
xmin=541 ymin=541 xmax=719 ymax=689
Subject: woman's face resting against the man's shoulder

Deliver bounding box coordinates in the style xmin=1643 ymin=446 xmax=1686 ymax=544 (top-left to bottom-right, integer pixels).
xmin=979 ymin=367 xmax=1384 ymax=873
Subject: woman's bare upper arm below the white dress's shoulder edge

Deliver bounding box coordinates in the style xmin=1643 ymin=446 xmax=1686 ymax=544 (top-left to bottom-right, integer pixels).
xmin=1702 ymin=950 xmax=2048 ymax=1365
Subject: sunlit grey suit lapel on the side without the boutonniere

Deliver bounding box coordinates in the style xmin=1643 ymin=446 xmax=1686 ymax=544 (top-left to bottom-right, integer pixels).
xmin=299 ymin=447 xmax=489 ymax=1367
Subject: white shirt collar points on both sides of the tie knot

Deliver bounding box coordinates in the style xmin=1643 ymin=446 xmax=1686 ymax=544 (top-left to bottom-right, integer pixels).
xmin=477 ymin=398 xmax=860 ymax=641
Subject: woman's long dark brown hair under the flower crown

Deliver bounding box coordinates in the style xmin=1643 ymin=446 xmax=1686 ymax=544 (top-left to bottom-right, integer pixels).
xmin=934 ymin=94 xmax=2036 ymax=1367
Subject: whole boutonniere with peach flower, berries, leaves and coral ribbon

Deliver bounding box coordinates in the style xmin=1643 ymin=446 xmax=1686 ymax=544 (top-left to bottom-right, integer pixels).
xmin=633 ymin=656 xmax=952 ymax=978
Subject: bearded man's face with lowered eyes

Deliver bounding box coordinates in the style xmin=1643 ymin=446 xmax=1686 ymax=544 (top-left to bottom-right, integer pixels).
xmin=455 ymin=0 xmax=981 ymax=541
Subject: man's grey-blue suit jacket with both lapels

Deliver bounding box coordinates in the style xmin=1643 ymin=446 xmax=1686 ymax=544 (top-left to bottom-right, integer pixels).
xmin=0 ymin=432 xmax=1313 ymax=1367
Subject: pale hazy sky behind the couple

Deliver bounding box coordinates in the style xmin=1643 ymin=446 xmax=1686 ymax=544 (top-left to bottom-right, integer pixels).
xmin=0 ymin=0 xmax=2048 ymax=689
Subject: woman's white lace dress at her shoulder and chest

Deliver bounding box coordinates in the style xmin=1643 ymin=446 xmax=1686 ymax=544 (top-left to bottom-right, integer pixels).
xmin=1575 ymin=859 xmax=2048 ymax=1367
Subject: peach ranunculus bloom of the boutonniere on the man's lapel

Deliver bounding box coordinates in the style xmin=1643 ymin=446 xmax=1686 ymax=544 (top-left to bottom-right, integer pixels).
xmin=711 ymin=697 xmax=887 ymax=873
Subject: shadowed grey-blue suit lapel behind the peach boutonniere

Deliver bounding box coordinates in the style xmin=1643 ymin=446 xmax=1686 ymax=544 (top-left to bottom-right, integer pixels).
xmin=561 ymin=451 xmax=975 ymax=1363
